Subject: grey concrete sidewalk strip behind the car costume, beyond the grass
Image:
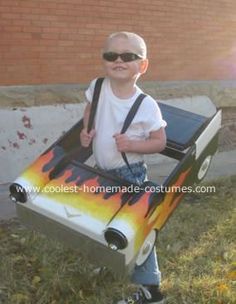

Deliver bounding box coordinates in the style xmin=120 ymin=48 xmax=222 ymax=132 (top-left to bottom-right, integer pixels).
xmin=0 ymin=150 xmax=236 ymax=221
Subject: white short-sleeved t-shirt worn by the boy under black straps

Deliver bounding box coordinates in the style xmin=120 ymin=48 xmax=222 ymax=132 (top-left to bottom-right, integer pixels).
xmin=85 ymin=78 xmax=166 ymax=170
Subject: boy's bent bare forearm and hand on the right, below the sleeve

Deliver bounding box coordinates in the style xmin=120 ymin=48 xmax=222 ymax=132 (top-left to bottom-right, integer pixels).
xmin=114 ymin=128 xmax=166 ymax=154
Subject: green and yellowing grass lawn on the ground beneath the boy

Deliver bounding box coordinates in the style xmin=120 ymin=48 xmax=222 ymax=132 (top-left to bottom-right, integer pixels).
xmin=0 ymin=177 xmax=236 ymax=304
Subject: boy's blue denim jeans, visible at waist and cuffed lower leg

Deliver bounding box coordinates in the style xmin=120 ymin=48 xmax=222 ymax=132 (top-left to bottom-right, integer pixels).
xmin=108 ymin=162 xmax=161 ymax=286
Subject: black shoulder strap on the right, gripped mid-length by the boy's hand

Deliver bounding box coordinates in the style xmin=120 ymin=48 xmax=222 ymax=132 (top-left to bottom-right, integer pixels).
xmin=120 ymin=94 xmax=146 ymax=174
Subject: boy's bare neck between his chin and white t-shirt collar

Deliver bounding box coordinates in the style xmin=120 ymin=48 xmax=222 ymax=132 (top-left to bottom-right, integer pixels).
xmin=110 ymin=79 xmax=136 ymax=99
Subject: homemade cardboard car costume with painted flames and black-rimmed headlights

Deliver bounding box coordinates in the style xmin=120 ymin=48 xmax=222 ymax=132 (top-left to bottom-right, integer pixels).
xmin=10 ymin=85 xmax=221 ymax=274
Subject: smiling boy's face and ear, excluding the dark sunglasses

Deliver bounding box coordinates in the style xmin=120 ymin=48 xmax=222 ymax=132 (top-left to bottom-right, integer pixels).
xmin=103 ymin=37 xmax=148 ymax=81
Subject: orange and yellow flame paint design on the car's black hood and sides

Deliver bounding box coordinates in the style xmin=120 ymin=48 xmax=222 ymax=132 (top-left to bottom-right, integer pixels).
xmin=18 ymin=142 xmax=191 ymax=252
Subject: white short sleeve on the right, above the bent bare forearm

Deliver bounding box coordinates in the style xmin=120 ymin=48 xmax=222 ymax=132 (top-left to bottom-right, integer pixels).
xmin=143 ymin=97 xmax=167 ymax=137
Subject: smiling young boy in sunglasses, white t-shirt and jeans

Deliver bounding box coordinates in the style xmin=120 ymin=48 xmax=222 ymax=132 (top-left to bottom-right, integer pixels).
xmin=80 ymin=32 xmax=166 ymax=304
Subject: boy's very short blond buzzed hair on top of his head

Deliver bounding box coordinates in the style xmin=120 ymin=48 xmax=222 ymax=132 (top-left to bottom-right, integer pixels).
xmin=106 ymin=32 xmax=147 ymax=58
